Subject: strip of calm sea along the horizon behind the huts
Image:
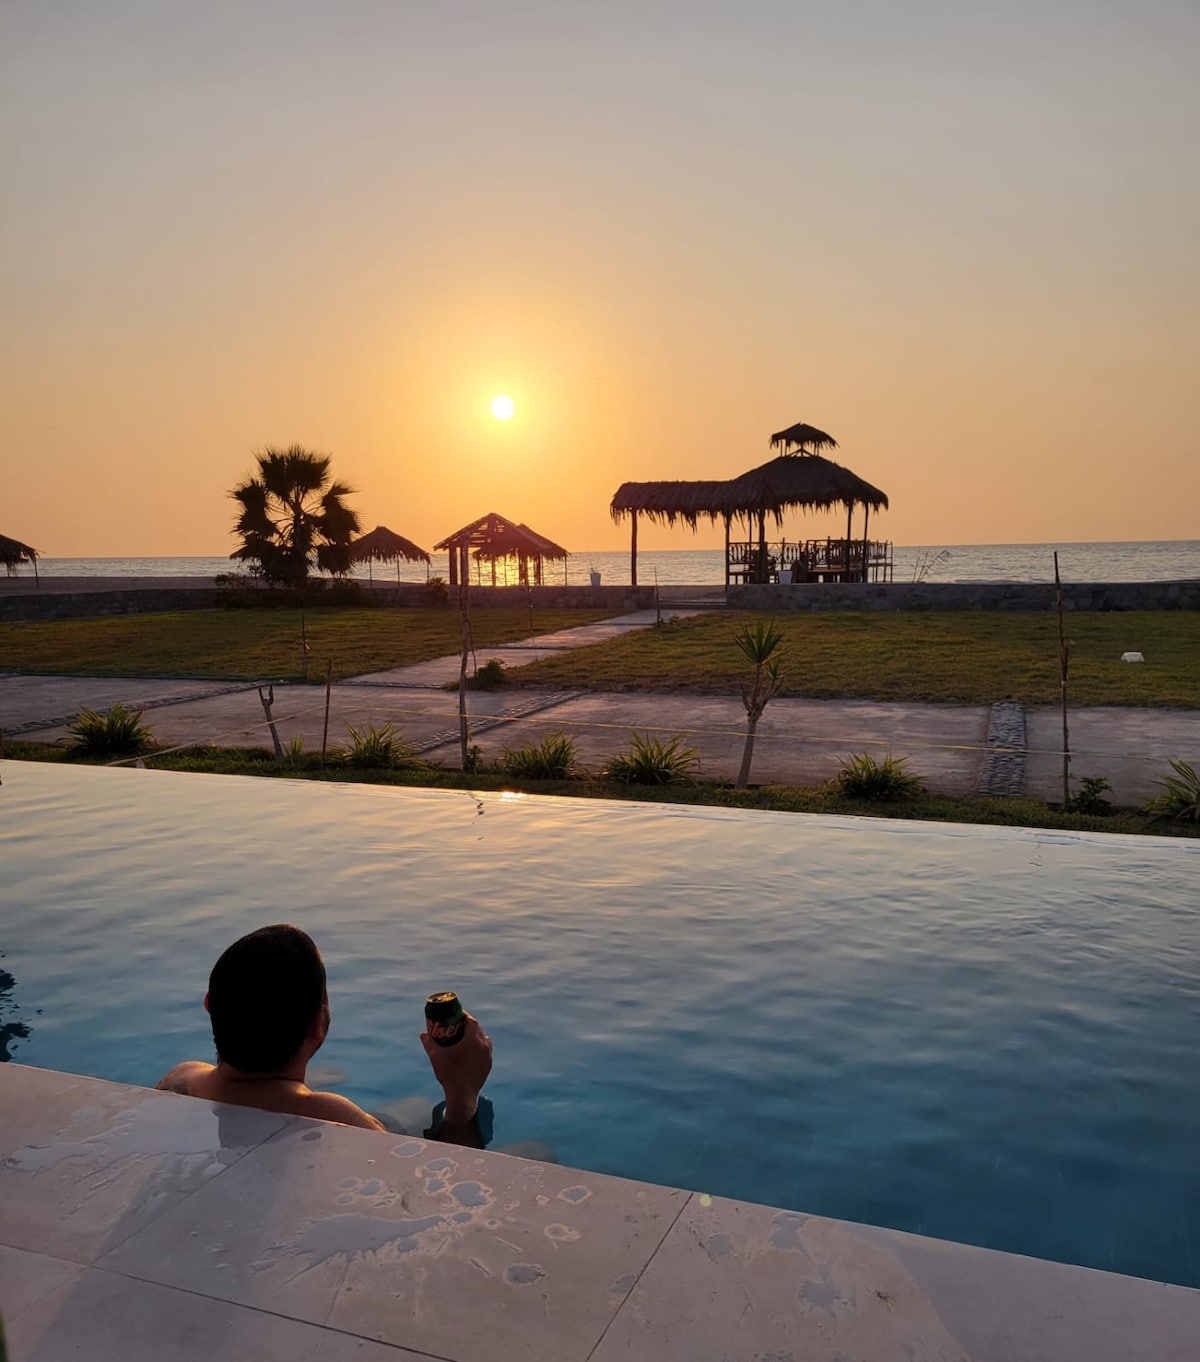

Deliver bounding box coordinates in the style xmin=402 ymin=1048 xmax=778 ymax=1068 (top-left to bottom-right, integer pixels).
xmin=20 ymin=539 xmax=1200 ymax=586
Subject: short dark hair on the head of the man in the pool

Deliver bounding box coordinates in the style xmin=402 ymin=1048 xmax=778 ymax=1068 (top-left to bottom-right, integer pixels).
xmin=208 ymin=922 xmax=326 ymax=1073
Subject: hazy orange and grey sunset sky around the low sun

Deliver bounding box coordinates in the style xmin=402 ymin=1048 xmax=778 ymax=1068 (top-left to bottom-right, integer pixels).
xmin=0 ymin=0 xmax=1200 ymax=557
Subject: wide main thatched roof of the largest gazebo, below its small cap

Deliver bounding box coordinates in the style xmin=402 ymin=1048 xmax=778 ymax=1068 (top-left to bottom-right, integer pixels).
xmin=609 ymin=454 xmax=888 ymax=530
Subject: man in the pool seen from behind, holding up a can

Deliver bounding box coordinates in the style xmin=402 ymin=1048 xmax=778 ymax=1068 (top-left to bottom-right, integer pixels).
xmin=157 ymin=923 xmax=492 ymax=1150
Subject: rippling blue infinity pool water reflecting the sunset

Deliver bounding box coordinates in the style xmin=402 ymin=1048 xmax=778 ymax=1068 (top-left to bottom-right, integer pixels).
xmin=0 ymin=761 xmax=1200 ymax=1286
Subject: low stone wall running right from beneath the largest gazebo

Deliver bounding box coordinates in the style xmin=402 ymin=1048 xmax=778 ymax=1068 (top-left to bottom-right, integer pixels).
xmin=726 ymin=577 xmax=1200 ymax=610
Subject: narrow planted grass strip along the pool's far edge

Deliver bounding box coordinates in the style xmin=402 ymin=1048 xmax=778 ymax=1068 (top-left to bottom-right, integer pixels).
xmin=5 ymin=741 xmax=1200 ymax=838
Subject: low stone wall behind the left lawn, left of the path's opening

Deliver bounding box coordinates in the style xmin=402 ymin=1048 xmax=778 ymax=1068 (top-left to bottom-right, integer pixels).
xmin=0 ymin=583 xmax=654 ymax=621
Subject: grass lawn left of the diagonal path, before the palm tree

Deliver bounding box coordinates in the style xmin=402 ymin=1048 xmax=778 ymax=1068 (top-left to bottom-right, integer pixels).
xmin=0 ymin=609 xmax=613 ymax=681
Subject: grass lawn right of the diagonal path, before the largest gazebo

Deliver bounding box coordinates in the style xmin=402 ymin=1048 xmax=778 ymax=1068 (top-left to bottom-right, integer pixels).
xmin=512 ymin=610 xmax=1200 ymax=710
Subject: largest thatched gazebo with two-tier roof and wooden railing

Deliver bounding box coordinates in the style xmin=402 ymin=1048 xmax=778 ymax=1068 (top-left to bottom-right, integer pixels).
xmin=609 ymin=422 xmax=891 ymax=586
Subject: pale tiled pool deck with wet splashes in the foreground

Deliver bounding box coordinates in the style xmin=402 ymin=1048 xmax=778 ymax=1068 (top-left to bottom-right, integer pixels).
xmin=0 ymin=1064 xmax=1200 ymax=1362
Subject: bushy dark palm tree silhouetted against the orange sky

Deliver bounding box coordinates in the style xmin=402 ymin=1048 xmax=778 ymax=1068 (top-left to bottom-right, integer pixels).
xmin=230 ymin=444 xmax=360 ymax=587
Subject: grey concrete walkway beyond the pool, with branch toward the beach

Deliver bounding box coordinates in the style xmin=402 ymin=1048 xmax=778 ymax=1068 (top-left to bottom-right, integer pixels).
xmin=0 ymin=607 xmax=1200 ymax=805
